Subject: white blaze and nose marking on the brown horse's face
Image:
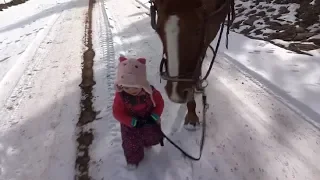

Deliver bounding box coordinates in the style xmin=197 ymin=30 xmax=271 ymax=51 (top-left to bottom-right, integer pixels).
xmin=165 ymin=15 xmax=181 ymax=102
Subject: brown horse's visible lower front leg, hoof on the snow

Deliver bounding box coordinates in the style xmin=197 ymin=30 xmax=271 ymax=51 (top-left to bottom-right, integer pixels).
xmin=184 ymin=98 xmax=200 ymax=130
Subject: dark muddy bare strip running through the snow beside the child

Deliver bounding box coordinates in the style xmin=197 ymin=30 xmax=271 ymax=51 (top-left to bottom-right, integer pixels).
xmin=75 ymin=0 xmax=96 ymax=180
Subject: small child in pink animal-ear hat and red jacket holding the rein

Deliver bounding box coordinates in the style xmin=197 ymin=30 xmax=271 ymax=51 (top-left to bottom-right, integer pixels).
xmin=113 ymin=56 xmax=164 ymax=169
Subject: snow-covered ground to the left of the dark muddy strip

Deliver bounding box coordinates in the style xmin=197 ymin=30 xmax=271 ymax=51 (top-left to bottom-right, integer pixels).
xmin=0 ymin=0 xmax=88 ymax=180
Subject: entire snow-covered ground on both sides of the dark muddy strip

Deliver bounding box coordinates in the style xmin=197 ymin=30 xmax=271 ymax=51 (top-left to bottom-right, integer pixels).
xmin=0 ymin=0 xmax=320 ymax=180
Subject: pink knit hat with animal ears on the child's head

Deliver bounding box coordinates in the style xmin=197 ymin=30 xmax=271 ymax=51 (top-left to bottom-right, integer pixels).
xmin=115 ymin=56 xmax=156 ymax=106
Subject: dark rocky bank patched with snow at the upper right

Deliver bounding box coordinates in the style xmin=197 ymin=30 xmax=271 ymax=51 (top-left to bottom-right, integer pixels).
xmin=233 ymin=0 xmax=320 ymax=53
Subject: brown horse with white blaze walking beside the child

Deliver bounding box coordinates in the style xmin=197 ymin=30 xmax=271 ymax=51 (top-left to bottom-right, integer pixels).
xmin=151 ymin=0 xmax=234 ymax=128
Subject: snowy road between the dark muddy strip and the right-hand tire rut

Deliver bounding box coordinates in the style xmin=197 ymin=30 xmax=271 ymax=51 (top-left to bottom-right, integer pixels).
xmin=91 ymin=0 xmax=320 ymax=180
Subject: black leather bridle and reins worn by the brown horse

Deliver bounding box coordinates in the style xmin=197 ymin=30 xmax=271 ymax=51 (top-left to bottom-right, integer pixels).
xmin=149 ymin=0 xmax=235 ymax=161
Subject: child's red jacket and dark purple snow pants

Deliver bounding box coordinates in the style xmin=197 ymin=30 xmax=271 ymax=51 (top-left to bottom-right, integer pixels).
xmin=113 ymin=88 xmax=164 ymax=165
